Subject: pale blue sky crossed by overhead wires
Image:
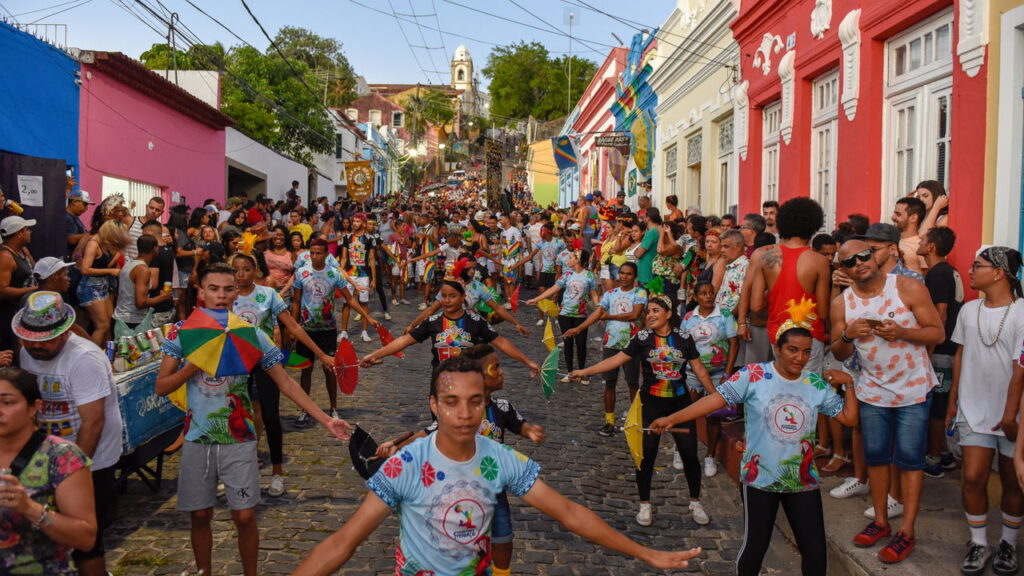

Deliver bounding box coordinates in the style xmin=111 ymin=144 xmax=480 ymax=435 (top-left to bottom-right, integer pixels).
xmin=0 ymin=0 xmax=676 ymax=87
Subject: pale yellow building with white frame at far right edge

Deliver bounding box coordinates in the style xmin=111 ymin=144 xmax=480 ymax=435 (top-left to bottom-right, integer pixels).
xmin=983 ymin=0 xmax=1024 ymax=249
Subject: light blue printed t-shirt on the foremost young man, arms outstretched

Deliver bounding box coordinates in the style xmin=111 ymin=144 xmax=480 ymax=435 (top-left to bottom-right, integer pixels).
xmin=367 ymin=433 xmax=541 ymax=576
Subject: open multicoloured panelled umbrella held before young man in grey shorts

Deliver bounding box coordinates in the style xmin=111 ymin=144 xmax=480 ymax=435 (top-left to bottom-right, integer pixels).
xmin=178 ymin=308 xmax=263 ymax=377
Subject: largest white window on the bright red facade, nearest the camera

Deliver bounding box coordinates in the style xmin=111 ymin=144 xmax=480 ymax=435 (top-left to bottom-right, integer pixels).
xmin=882 ymin=10 xmax=953 ymax=212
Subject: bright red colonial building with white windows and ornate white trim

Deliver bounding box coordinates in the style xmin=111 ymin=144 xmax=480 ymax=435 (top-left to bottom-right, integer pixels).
xmin=731 ymin=0 xmax=988 ymax=266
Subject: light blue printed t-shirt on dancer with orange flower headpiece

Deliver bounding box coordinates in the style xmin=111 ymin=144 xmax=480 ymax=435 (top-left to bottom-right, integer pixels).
xmin=718 ymin=362 xmax=843 ymax=492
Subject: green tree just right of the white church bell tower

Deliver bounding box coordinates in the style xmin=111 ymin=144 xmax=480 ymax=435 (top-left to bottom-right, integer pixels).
xmin=483 ymin=42 xmax=597 ymax=120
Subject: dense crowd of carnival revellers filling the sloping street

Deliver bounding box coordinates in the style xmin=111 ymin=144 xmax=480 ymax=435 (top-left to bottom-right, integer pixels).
xmin=0 ymin=174 xmax=1024 ymax=576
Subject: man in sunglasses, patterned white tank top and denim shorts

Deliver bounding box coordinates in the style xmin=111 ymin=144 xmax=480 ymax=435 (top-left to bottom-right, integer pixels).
xmin=830 ymin=236 xmax=945 ymax=564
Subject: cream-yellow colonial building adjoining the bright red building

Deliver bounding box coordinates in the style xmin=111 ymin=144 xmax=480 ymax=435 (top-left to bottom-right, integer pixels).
xmin=650 ymin=0 xmax=739 ymax=215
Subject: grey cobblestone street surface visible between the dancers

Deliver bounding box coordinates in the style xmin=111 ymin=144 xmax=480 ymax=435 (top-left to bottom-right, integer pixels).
xmin=106 ymin=295 xmax=799 ymax=576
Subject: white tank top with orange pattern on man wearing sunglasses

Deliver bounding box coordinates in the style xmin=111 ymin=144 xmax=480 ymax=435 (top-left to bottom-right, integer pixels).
xmin=843 ymin=274 xmax=937 ymax=408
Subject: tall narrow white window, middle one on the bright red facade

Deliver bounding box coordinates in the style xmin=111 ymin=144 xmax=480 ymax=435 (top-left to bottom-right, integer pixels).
xmin=811 ymin=70 xmax=839 ymax=230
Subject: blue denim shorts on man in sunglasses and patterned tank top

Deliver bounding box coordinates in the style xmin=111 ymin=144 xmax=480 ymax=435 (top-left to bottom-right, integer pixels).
xmin=859 ymin=394 xmax=932 ymax=470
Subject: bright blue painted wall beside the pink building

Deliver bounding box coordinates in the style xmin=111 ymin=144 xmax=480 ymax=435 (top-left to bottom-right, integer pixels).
xmin=0 ymin=22 xmax=79 ymax=166
